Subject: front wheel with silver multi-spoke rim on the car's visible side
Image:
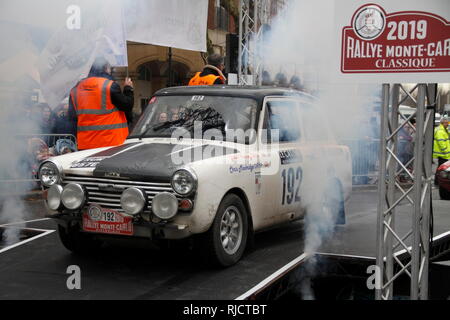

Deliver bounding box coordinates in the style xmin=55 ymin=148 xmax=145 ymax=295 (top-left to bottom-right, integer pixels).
xmin=201 ymin=194 xmax=248 ymax=267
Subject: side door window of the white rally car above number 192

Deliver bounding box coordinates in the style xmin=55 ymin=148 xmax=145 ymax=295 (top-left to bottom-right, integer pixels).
xmin=262 ymin=99 xmax=300 ymax=144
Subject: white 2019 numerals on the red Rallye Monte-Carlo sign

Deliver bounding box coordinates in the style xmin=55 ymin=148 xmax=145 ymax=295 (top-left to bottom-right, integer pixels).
xmin=387 ymin=20 xmax=427 ymax=40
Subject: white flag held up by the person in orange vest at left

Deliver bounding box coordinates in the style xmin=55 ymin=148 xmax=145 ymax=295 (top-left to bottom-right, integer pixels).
xmin=37 ymin=0 xmax=128 ymax=107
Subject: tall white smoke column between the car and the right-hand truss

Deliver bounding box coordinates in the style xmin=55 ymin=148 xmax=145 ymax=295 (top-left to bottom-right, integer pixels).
xmin=257 ymin=0 xmax=381 ymax=299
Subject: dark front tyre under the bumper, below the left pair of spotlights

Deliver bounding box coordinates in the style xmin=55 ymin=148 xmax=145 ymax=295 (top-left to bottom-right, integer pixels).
xmin=58 ymin=225 xmax=101 ymax=254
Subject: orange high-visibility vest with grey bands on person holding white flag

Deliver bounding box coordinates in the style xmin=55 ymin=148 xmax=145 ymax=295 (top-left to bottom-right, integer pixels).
xmin=70 ymin=77 xmax=128 ymax=150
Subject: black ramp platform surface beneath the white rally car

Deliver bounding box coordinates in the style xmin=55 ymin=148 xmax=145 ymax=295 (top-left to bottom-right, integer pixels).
xmin=0 ymin=208 xmax=303 ymax=300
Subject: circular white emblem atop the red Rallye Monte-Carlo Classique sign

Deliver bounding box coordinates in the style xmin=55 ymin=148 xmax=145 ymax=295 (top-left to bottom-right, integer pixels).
xmin=353 ymin=5 xmax=386 ymax=40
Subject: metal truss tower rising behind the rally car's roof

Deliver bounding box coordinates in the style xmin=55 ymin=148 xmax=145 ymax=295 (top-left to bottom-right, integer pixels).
xmin=238 ymin=0 xmax=276 ymax=85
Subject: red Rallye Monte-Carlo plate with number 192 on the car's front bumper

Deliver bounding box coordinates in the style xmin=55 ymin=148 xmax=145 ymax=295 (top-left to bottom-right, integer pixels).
xmin=83 ymin=205 xmax=133 ymax=236
